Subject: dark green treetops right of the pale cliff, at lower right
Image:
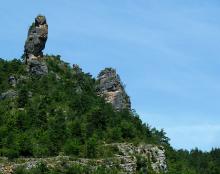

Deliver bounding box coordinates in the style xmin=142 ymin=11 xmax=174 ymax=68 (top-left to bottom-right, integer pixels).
xmin=166 ymin=147 xmax=220 ymax=174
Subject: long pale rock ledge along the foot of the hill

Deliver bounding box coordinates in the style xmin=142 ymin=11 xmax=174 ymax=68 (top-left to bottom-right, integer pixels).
xmin=0 ymin=143 xmax=167 ymax=174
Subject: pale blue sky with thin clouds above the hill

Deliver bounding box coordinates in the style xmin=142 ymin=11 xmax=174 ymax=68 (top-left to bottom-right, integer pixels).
xmin=0 ymin=0 xmax=220 ymax=150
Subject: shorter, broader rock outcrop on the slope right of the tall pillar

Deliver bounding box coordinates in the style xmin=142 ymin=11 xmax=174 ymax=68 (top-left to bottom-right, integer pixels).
xmin=97 ymin=68 xmax=131 ymax=110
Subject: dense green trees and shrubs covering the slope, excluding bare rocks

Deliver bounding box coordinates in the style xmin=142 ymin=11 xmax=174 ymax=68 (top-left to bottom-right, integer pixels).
xmin=0 ymin=56 xmax=220 ymax=174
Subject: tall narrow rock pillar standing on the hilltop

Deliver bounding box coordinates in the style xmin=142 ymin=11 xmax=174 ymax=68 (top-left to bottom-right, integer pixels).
xmin=24 ymin=15 xmax=48 ymax=75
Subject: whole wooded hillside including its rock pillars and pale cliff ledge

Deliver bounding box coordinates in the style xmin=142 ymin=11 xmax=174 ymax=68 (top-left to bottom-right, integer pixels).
xmin=0 ymin=16 xmax=220 ymax=174
